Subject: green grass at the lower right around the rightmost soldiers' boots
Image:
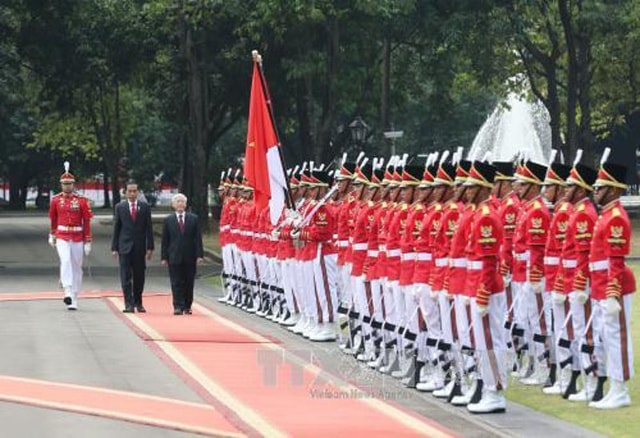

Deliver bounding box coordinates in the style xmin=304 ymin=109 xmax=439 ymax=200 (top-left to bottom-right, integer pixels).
xmin=507 ymin=262 xmax=640 ymax=437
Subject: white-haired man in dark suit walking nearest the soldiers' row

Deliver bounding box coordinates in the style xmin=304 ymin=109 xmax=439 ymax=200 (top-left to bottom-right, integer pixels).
xmin=160 ymin=193 xmax=204 ymax=315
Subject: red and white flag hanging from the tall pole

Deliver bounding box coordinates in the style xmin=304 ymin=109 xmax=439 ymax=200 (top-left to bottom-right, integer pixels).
xmin=244 ymin=62 xmax=287 ymax=225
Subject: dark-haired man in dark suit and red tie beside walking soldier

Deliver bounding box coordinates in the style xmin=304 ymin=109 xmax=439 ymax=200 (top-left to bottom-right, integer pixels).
xmin=111 ymin=183 xmax=153 ymax=313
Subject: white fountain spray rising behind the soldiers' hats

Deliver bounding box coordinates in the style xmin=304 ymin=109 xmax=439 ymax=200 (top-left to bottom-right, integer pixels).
xmin=467 ymin=93 xmax=551 ymax=164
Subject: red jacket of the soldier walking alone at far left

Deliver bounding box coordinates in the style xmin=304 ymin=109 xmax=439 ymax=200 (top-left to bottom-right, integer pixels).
xmin=49 ymin=193 xmax=93 ymax=242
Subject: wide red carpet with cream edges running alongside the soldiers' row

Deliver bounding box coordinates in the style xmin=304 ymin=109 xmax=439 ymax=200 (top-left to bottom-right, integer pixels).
xmin=110 ymin=296 xmax=453 ymax=437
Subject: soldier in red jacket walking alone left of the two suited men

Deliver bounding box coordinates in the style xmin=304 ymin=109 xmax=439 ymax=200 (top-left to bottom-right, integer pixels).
xmin=49 ymin=161 xmax=93 ymax=310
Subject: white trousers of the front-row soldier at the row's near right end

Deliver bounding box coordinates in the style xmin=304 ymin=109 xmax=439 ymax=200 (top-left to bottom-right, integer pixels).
xmin=471 ymin=292 xmax=508 ymax=391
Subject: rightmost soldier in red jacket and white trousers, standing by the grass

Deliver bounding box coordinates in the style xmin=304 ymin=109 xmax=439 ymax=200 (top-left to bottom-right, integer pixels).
xmin=589 ymin=148 xmax=636 ymax=409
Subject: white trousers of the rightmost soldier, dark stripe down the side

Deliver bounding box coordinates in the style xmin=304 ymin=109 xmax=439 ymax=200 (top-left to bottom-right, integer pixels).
xmin=602 ymin=294 xmax=634 ymax=382
